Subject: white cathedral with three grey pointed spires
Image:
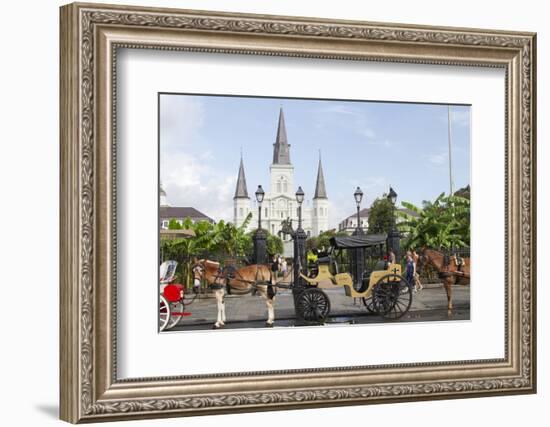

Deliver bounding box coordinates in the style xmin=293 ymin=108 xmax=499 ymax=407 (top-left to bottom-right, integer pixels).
xmin=233 ymin=108 xmax=329 ymax=256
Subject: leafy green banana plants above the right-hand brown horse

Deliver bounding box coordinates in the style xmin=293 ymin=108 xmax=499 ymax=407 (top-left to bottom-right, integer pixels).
xmin=398 ymin=193 xmax=470 ymax=249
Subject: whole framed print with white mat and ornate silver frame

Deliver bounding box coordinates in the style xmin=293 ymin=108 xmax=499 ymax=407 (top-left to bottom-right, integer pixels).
xmin=60 ymin=4 xmax=536 ymax=423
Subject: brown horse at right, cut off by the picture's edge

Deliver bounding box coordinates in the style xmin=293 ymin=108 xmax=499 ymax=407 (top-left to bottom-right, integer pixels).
xmin=417 ymin=249 xmax=470 ymax=311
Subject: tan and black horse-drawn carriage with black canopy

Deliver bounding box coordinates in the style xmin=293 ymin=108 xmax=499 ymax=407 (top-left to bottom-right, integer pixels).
xmin=295 ymin=234 xmax=412 ymax=321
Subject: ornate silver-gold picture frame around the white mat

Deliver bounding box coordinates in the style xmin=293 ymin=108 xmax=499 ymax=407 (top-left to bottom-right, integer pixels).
xmin=60 ymin=4 xmax=536 ymax=423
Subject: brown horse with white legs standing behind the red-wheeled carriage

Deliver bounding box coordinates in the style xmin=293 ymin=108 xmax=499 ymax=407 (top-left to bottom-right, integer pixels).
xmin=193 ymin=259 xmax=276 ymax=329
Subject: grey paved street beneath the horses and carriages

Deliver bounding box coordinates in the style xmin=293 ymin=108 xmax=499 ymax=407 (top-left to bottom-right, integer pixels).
xmin=171 ymin=285 xmax=470 ymax=331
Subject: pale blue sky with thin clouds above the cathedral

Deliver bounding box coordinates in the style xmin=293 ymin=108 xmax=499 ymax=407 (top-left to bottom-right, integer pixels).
xmin=160 ymin=94 xmax=470 ymax=227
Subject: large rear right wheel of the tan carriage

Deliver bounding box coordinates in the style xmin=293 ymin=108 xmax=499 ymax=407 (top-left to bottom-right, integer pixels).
xmin=372 ymin=274 xmax=412 ymax=320
